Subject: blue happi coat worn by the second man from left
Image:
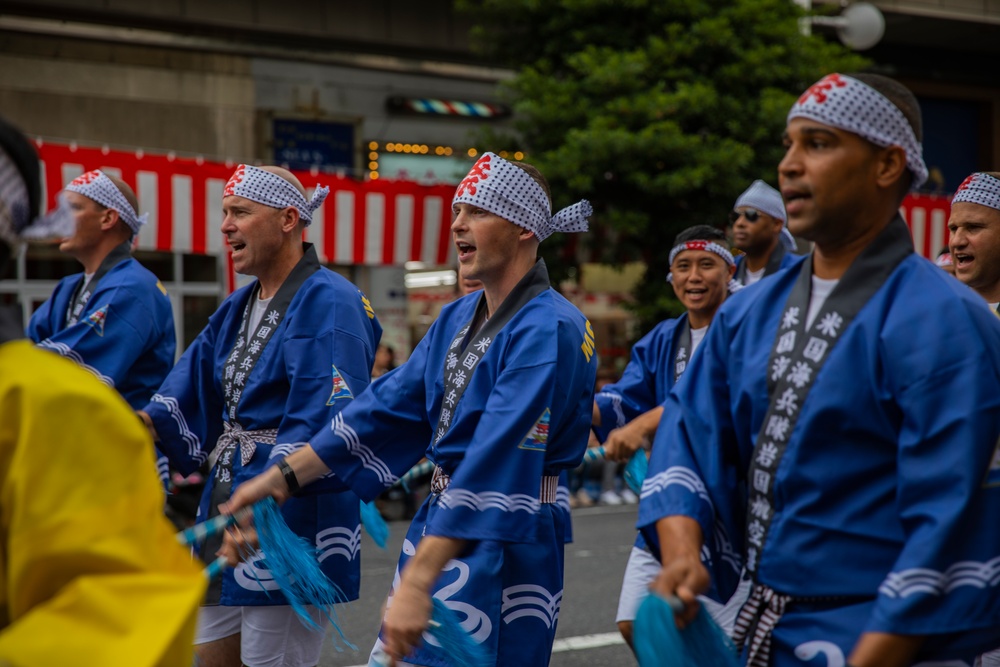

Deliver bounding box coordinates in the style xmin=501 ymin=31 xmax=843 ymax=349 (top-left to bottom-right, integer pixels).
xmin=145 ymin=269 xmax=382 ymax=605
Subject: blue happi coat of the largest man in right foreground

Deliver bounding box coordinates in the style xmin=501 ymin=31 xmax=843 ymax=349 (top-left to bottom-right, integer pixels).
xmin=639 ymin=253 xmax=1000 ymax=667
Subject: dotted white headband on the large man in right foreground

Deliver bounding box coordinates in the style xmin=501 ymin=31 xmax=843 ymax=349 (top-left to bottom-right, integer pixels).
xmin=788 ymin=74 xmax=927 ymax=190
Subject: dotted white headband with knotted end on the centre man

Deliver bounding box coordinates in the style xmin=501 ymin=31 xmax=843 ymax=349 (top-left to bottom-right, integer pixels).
xmin=452 ymin=153 xmax=594 ymax=241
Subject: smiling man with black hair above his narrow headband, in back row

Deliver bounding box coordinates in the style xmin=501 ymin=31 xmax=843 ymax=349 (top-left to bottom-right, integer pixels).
xmin=594 ymin=225 xmax=740 ymax=646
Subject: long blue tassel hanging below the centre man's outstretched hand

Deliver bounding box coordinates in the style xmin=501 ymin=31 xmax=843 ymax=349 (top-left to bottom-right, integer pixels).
xmin=253 ymin=498 xmax=357 ymax=650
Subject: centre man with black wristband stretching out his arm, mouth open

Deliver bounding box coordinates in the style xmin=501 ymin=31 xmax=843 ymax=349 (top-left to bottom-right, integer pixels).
xmin=226 ymin=153 xmax=597 ymax=667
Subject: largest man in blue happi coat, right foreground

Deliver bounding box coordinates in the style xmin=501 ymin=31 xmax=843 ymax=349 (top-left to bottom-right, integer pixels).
xmin=639 ymin=74 xmax=1000 ymax=667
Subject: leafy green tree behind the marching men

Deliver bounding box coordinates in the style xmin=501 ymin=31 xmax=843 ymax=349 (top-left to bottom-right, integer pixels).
xmin=457 ymin=0 xmax=866 ymax=330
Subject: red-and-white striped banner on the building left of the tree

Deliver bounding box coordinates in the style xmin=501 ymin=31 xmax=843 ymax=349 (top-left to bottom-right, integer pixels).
xmin=36 ymin=141 xmax=455 ymax=266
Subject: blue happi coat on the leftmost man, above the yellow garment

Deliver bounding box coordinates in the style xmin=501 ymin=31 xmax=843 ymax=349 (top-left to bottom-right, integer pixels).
xmin=27 ymin=252 xmax=176 ymax=409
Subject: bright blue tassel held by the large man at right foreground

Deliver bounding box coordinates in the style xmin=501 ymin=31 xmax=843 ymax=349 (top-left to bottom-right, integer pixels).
xmin=633 ymin=593 xmax=739 ymax=667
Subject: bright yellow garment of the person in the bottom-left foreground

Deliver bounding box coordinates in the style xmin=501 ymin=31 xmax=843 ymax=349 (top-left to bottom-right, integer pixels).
xmin=0 ymin=342 xmax=207 ymax=667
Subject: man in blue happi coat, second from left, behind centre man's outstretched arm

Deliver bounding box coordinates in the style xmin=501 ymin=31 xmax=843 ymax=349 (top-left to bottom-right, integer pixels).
xmin=139 ymin=165 xmax=382 ymax=667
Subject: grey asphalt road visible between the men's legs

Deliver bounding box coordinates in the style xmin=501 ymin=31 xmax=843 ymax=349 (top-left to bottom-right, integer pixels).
xmin=319 ymin=505 xmax=636 ymax=667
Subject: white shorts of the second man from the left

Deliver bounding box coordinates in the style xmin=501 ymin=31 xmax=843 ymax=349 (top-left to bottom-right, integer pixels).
xmin=194 ymin=605 xmax=330 ymax=667
